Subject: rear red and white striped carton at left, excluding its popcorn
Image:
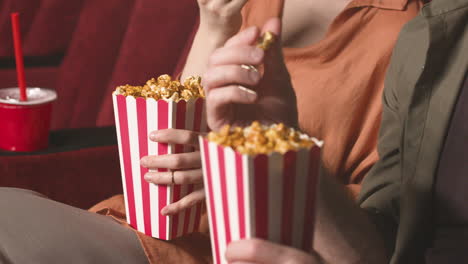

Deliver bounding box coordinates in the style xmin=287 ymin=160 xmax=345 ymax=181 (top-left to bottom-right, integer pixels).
xmin=112 ymin=94 xmax=207 ymax=240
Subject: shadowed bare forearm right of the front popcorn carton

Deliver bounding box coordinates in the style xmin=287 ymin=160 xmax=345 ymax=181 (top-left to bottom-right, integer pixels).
xmin=313 ymin=173 xmax=388 ymax=263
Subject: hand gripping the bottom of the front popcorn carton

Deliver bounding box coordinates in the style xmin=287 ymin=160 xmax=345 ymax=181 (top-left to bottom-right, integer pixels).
xmin=226 ymin=239 xmax=322 ymax=264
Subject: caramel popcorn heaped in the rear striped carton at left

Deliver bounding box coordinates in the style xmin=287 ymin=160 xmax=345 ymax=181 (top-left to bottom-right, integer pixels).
xmin=115 ymin=74 xmax=205 ymax=102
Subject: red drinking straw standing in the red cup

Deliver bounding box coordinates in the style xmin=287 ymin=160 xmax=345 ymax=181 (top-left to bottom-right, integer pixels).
xmin=11 ymin=13 xmax=28 ymax=101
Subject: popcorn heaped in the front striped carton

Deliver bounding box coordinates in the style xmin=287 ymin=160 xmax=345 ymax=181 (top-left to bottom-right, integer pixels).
xmin=208 ymin=121 xmax=315 ymax=155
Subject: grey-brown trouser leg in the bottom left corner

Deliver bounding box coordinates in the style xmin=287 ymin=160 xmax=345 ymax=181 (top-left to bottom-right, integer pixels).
xmin=0 ymin=188 xmax=148 ymax=264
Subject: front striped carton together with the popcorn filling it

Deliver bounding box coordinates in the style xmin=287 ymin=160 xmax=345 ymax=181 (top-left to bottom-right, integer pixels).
xmin=199 ymin=122 xmax=323 ymax=264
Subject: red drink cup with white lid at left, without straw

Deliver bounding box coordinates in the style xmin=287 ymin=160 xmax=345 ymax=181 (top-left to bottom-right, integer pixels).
xmin=0 ymin=88 xmax=57 ymax=152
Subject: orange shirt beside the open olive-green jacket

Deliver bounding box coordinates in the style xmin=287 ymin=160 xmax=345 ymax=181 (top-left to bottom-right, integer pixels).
xmin=243 ymin=0 xmax=423 ymax=195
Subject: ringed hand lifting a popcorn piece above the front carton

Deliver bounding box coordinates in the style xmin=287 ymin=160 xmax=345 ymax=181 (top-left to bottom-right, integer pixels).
xmin=203 ymin=18 xmax=297 ymax=130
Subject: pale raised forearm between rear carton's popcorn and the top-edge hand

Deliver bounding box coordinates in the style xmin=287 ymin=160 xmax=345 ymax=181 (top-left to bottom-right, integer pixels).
xmin=180 ymin=26 xmax=230 ymax=80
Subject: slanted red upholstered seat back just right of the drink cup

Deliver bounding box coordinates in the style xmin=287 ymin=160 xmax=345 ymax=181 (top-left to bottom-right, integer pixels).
xmin=52 ymin=0 xmax=137 ymax=129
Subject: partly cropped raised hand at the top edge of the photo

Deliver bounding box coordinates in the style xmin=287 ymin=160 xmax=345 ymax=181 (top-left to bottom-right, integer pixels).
xmin=198 ymin=0 xmax=247 ymax=37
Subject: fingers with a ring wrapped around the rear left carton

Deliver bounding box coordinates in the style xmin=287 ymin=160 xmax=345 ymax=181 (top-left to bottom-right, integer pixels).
xmin=141 ymin=129 xmax=205 ymax=215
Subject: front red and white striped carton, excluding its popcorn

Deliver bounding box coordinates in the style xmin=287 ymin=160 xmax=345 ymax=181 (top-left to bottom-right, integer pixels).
xmin=199 ymin=137 xmax=322 ymax=264
